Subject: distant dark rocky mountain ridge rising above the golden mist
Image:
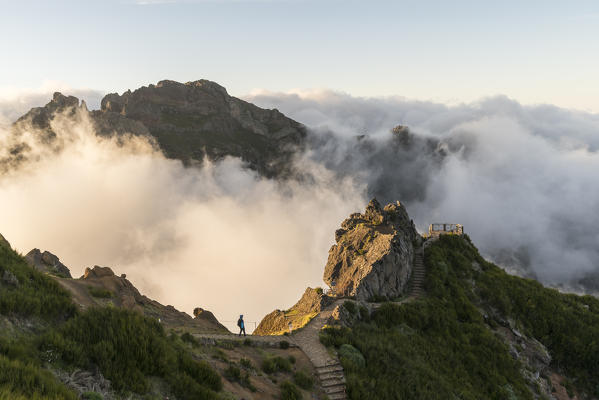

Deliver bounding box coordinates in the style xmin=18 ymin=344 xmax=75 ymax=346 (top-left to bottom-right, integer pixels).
xmin=8 ymin=80 xmax=306 ymax=177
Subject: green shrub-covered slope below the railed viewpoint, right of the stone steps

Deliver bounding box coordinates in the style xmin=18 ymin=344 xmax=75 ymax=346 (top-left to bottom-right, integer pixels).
xmin=321 ymin=236 xmax=599 ymax=400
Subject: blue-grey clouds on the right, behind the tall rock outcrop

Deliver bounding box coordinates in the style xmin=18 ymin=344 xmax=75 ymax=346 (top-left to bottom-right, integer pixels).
xmin=246 ymin=91 xmax=599 ymax=292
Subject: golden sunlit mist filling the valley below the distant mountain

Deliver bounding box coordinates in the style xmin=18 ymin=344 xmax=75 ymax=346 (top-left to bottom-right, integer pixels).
xmin=0 ymin=105 xmax=366 ymax=330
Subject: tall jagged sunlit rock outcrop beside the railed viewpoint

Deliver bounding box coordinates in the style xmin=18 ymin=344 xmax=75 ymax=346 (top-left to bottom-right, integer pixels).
xmin=324 ymin=199 xmax=419 ymax=301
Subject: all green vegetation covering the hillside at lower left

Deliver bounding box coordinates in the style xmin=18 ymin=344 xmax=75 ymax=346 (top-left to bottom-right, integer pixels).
xmin=0 ymin=239 xmax=222 ymax=399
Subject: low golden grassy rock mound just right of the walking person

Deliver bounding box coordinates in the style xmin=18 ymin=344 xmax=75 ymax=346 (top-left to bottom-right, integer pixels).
xmin=254 ymin=288 xmax=332 ymax=335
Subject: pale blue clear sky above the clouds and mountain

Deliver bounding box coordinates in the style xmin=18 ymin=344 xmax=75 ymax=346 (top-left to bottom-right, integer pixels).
xmin=0 ymin=0 xmax=599 ymax=112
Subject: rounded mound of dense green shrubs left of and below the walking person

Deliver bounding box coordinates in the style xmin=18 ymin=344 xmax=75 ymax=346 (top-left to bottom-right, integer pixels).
xmin=40 ymin=307 xmax=222 ymax=398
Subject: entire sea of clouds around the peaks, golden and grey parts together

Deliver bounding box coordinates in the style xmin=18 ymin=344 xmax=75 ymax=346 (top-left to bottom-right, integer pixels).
xmin=0 ymin=91 xmax=599 ymax=327
